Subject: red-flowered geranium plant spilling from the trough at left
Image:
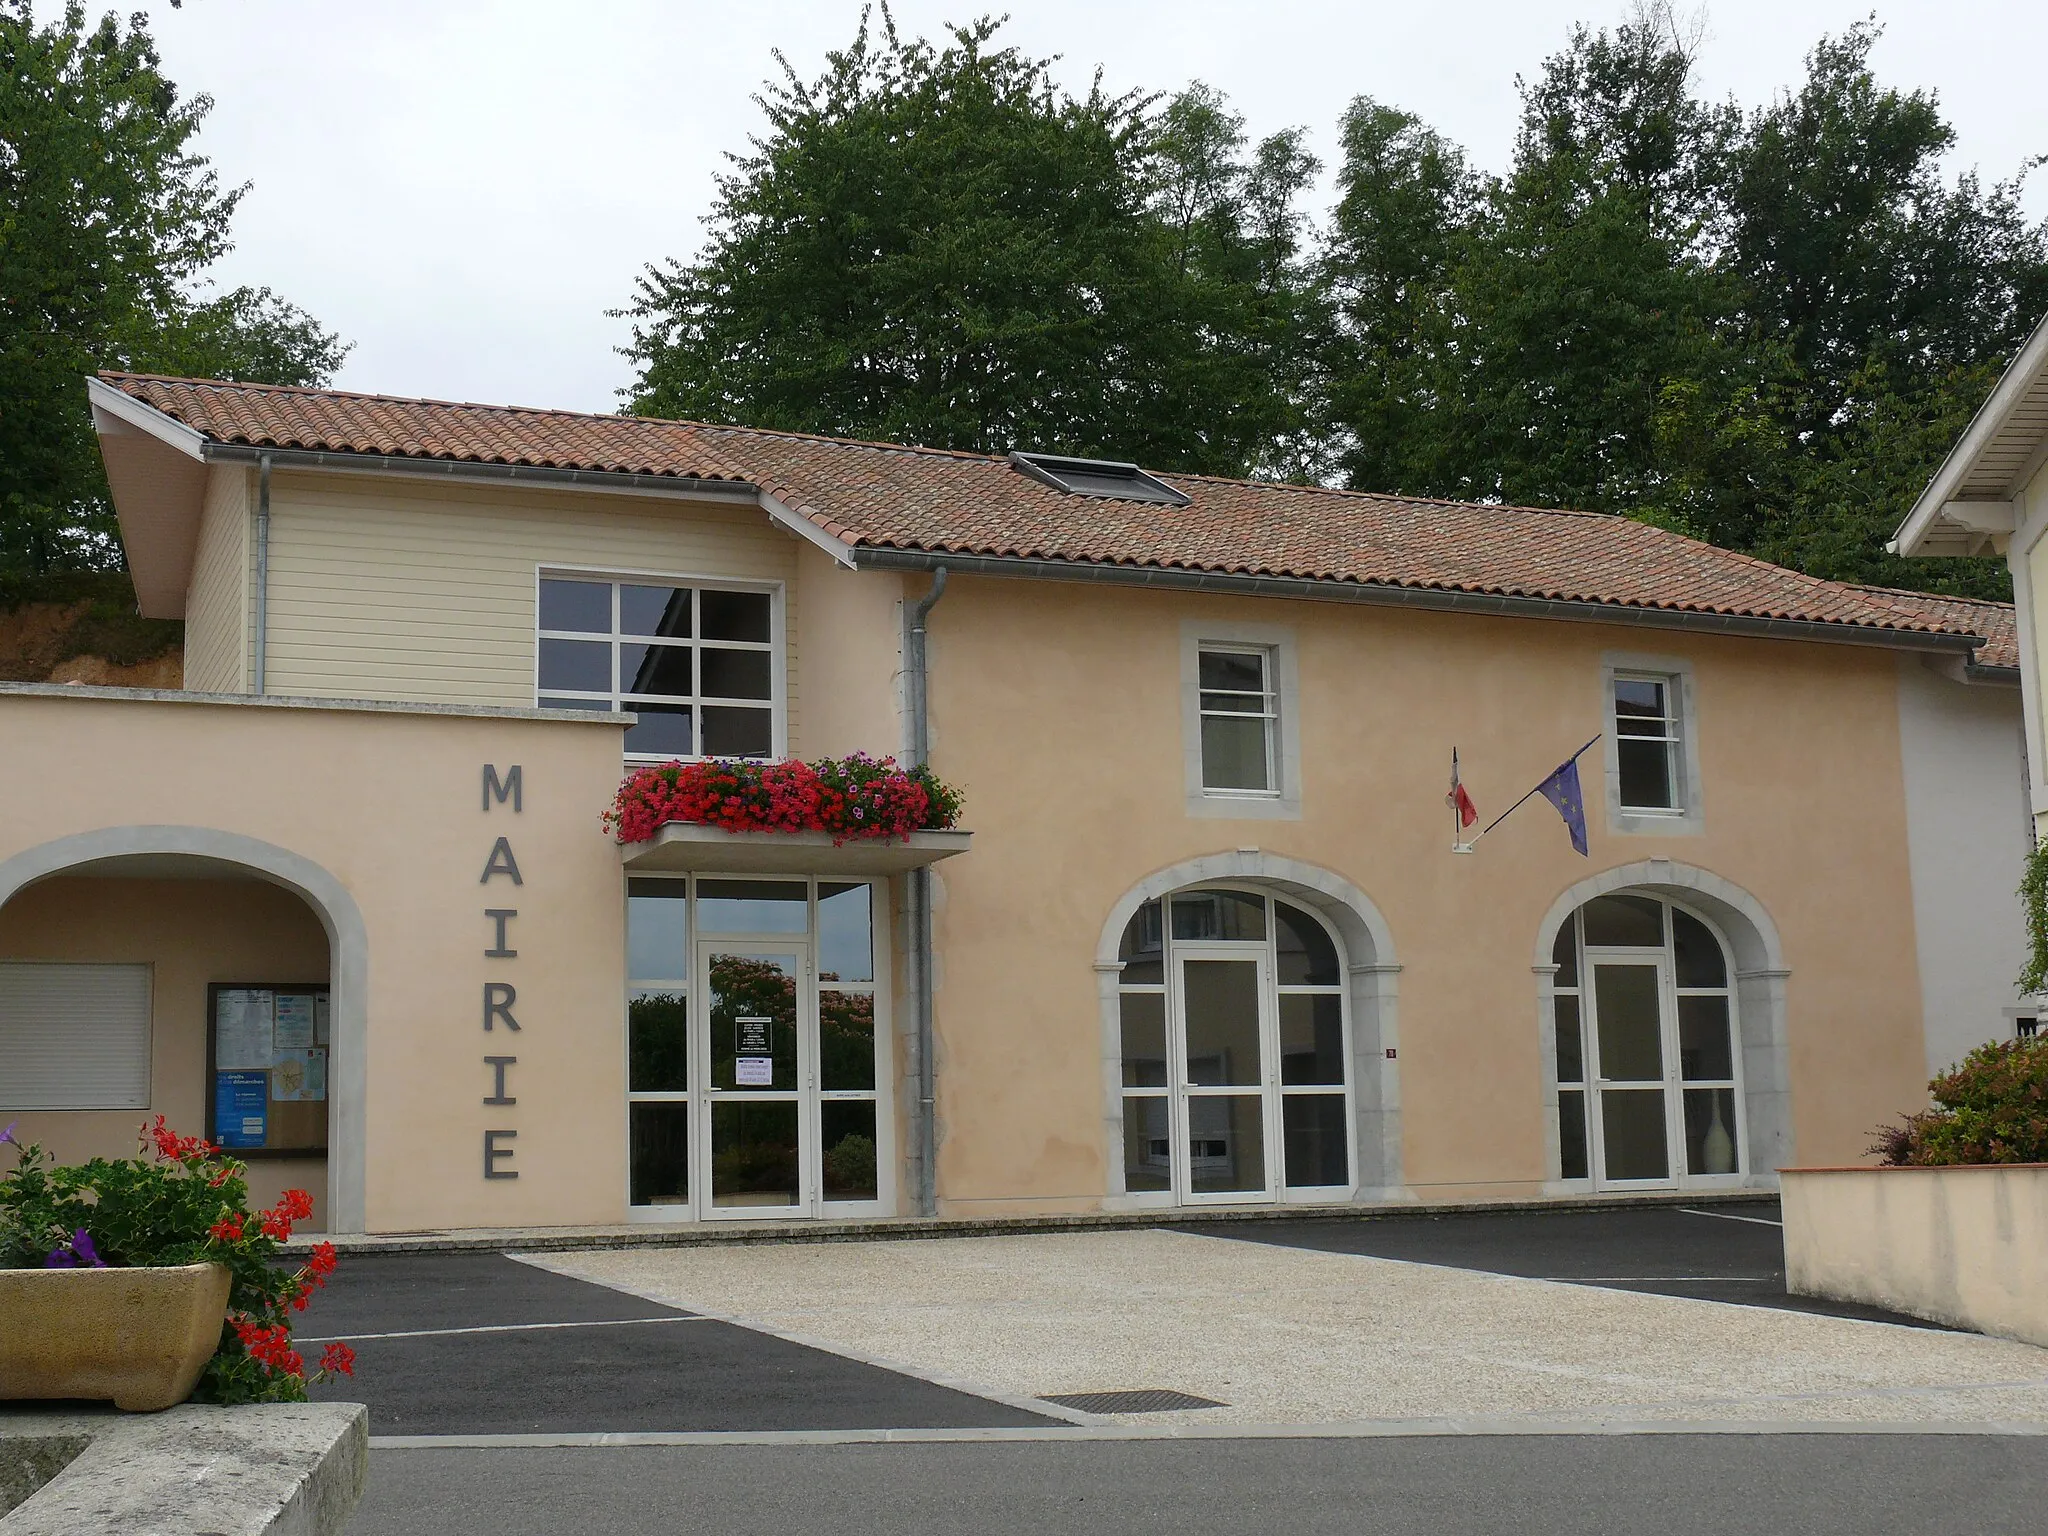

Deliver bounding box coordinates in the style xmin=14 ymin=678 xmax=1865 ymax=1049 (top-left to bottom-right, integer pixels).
xmin=0 ymin=1116 xmax=354 ymax=1403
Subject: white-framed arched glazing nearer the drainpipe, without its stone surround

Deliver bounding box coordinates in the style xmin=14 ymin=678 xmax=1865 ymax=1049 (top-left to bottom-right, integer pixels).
xmin=1116 ymin=887 xmax=1356 ymax=1204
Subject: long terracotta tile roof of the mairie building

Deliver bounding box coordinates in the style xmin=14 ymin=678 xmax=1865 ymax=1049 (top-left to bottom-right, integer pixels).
xmin=100 ymin=373 xmax=2017 ymax=666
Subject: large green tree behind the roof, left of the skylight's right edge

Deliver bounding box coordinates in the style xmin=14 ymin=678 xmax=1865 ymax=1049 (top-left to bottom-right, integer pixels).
xmin=623 ymin=8 xmax=1315 ymax=473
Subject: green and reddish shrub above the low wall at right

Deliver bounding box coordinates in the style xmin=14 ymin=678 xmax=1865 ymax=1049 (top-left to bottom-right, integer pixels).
xmin=1870 ymin=1038 xmax=2048 ymax=1167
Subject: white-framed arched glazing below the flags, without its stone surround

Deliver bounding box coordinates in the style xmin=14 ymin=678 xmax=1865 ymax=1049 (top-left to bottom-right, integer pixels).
xmin=1550 ymin=891 xmax=1747 ymax=1190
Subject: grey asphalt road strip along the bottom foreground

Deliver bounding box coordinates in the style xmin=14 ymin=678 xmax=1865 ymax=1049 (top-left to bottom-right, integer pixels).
xmin=348 ymin=1434 xmax=2048 ymax=1536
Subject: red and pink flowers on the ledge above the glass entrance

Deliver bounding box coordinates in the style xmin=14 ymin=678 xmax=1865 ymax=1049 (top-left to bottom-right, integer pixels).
xmin=604 ymin=752 xmax=969 ymax=874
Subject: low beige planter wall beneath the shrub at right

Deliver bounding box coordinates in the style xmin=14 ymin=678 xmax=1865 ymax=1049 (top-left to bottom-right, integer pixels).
xmin=1778 ymin=1163 xmax=2048 ymax=1346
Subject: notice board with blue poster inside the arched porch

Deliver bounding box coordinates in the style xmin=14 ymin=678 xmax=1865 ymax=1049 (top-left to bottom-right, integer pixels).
xmin=207 ymin=981 xmax=330 ymax=1159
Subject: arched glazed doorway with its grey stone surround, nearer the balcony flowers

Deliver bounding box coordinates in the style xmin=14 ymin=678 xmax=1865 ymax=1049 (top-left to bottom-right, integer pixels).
xmin=1098 ymin=852 xmax=1399 ymax=1208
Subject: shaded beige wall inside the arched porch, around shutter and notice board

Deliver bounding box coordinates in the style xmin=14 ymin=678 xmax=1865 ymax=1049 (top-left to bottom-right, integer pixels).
xmin=0 ymin=877 xmax=328 ymax=1229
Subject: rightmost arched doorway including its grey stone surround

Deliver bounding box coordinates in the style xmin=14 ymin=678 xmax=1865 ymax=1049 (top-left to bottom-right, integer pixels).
xmin=1538 ymin=860 xmax=1788 ymax=1190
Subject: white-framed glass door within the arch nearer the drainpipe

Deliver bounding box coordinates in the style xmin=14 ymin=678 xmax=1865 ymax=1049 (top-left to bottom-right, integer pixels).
xmin=1174 ymin=944 xmax=1278 ymax=1202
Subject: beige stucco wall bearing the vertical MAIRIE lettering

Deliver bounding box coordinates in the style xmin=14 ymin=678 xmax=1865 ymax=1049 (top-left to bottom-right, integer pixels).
xmin=0 ymin=690 xmax=625 ymax=1231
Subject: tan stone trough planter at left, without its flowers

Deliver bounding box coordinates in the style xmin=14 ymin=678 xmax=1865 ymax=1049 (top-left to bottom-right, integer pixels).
xmin=0 ymin=1264 xmax=229 ymax=1413
